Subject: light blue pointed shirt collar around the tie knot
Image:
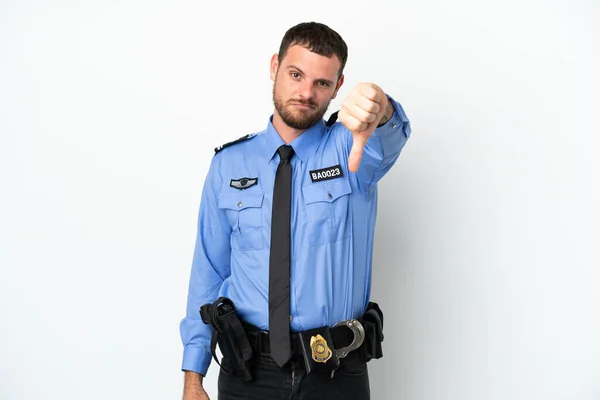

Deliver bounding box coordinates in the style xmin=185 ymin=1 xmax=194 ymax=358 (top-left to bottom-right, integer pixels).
xmin=261 ymin=115 xmax=326 ymax=163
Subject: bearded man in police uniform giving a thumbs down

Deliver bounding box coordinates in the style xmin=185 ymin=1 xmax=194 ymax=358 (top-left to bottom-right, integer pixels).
xmin=180 ymin=22 xmax=411 ymax=400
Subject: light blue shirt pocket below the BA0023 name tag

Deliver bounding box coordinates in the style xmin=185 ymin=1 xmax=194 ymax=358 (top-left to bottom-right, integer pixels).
xmin=302 ymin=179 xmax=352 ymax=246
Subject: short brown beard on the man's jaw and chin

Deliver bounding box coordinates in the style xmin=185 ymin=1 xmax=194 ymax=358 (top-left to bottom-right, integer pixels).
xmin=273 ymin=81 xmax=331 ymax=130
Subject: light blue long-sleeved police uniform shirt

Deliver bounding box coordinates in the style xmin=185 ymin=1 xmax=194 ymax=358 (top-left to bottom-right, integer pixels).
xmin=180 ymin=95 xmax=411 ymax=375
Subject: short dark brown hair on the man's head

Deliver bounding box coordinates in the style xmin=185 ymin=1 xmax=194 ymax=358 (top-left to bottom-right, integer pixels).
xmin=278 ymin=22 xmax=348 ymax=78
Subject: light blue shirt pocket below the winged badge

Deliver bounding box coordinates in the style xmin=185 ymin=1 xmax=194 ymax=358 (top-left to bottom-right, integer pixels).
xmin=219 ymin=192 xmax=264 ymax=250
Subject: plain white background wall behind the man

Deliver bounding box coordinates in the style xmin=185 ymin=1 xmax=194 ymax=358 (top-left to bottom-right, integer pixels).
xmin=0 ymin=0 xmax=600 ymax=400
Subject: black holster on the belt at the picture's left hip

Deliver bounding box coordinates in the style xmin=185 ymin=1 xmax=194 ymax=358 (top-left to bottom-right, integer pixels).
xmin=200 ymin=297 xmax=253 ymax=381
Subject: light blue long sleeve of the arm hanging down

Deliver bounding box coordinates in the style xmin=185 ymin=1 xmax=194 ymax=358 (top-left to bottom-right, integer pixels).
xmin=180 ymin=154 xmax=231 ymax=375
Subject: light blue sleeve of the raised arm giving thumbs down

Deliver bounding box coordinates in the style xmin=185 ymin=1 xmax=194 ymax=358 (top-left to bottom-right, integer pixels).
xmin=348 ymin=95 xmax=411 ymax=195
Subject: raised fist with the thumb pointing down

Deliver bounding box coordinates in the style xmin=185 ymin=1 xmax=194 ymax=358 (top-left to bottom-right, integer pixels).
xmin=338 ymin=83 xmax=391 ymax=172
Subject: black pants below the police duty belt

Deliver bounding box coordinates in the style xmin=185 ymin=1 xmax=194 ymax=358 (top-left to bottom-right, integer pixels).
xmin=217 ymin=352 xmax=370 ymax=400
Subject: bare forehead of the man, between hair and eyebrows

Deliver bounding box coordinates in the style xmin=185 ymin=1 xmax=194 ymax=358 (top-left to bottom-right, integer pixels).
xmin=281 ymin=45 xmax=342 ymax=80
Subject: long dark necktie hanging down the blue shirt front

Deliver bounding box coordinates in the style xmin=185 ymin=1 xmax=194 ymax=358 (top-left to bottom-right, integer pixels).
xmin=269 ymin=145 xmax=294 ymax=366
